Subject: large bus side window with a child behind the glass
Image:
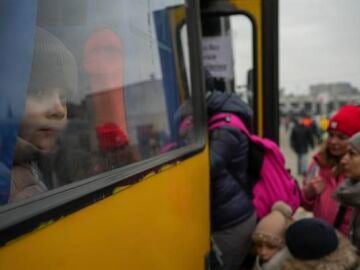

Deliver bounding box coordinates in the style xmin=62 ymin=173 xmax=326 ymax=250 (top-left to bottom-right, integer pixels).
xmin=2 ymin=0 xmax=195 ymax=206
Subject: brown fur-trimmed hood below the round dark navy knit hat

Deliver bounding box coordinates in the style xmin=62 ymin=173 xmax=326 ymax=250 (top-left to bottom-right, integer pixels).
xmin=282 ymin=233 xmax=360 ymax=270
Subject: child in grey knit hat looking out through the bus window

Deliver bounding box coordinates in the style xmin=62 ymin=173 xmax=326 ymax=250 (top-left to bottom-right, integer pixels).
xmin=9 ymin=28 xmax=94 ymax=202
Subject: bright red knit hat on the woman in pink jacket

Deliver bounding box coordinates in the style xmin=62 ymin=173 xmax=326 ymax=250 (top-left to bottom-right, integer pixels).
xmin=328 ymin=105 xmax=360 ymax=137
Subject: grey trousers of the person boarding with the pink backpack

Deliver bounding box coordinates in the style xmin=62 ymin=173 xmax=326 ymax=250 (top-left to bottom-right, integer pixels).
xmin=212 ymin=213 xmax=256 ymax=270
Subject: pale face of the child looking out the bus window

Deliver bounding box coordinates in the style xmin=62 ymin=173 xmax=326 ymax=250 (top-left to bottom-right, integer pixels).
xmin=19 ymin=88 xmax=67 ymax=152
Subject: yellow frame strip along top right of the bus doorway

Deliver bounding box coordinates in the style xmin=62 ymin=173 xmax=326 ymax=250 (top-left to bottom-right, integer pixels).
xmin=229 ymin=0 xmax=264 ymax=136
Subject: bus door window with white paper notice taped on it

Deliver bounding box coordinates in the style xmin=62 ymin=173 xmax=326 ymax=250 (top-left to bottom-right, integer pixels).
xmin=203 ymin=14 xmax=254 ymax=104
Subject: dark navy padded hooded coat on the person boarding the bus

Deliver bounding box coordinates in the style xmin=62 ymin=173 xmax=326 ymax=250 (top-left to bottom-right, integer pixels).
xmin=208 ymin=91 xmax=254 ymax=231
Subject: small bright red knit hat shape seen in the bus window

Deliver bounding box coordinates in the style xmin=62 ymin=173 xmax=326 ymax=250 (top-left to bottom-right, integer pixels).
xmin=96 ymin=123 xmax=128 ymax=151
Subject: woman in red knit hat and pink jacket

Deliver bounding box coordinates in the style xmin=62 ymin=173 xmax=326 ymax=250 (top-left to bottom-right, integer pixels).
xmin=301 ymin=105 xmax=360 ymax=235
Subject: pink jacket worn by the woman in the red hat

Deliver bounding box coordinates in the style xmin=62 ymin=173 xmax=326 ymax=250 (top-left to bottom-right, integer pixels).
xmin=302 ymin=155 xmax=352 ymax=235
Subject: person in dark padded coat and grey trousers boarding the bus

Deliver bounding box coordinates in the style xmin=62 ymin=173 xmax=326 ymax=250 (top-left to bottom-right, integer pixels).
xmin=207 ymin=91 xmax=256 ymax=270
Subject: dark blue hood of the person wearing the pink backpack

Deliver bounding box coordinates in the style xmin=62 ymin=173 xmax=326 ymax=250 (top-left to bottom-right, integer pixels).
xmin=207 ymin=91 xmax=253 ymax=130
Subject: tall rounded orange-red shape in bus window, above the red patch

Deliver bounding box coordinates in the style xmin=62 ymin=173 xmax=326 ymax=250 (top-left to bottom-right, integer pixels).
xmin=83 ymin=28 xmax=127 ymax=133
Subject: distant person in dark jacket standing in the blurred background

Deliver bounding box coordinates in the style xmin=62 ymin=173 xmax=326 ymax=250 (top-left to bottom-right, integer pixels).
xmin=290 ymin=118 xmax=314 ymax=175
